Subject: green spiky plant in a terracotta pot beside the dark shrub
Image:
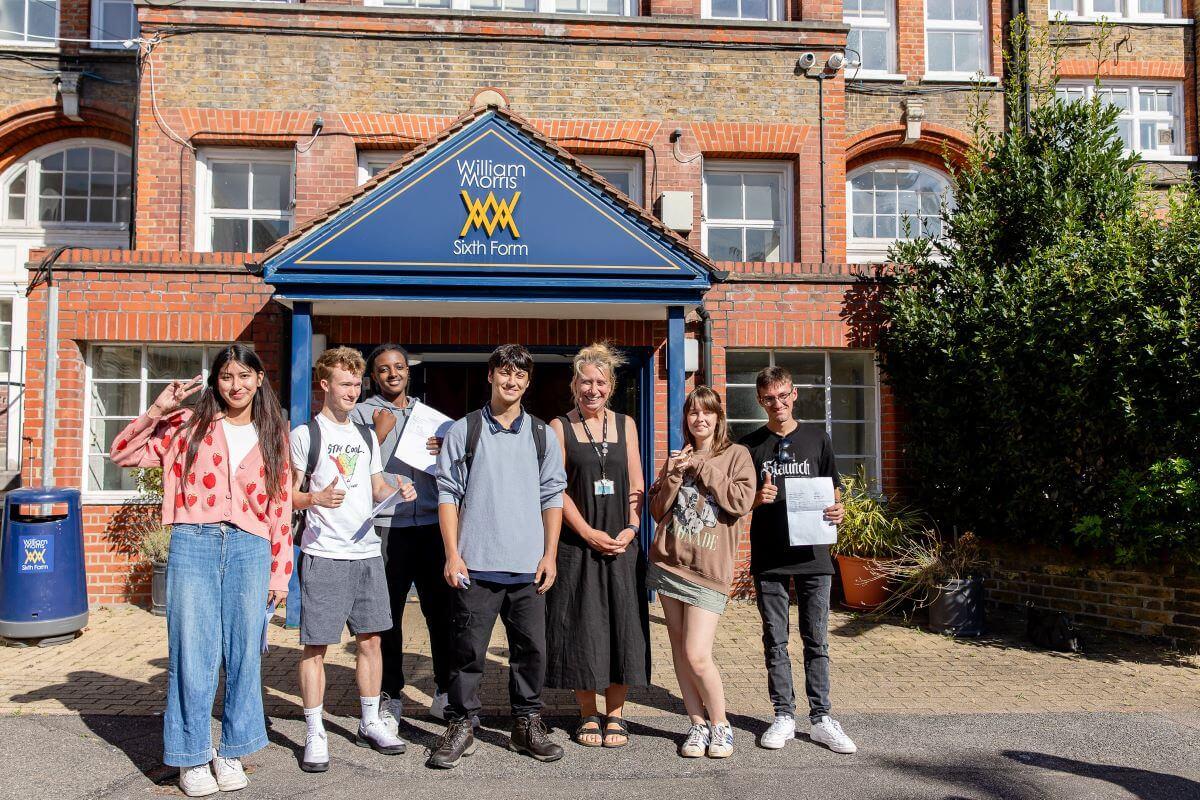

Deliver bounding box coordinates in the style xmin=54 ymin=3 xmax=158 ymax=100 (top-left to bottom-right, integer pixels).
xmin=832 ymin=467 xmax=920 ymax=609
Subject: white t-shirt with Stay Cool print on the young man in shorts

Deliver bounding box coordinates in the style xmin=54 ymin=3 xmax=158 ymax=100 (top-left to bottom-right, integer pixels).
xmin=292 ymin=414 xmax=383 ymax=559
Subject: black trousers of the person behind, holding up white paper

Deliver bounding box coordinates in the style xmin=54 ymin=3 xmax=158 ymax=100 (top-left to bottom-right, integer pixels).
xmin=376 ymin=525 xmax=454 ymax=697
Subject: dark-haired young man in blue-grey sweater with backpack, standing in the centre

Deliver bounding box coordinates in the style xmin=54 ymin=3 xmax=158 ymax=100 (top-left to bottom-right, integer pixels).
xmin=427 ymin=344 xmax=566 ymax=769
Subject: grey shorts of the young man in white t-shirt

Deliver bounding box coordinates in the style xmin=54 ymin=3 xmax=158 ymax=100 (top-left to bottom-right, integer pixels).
xmin=300 ymin=553 xmax=391 ymax=644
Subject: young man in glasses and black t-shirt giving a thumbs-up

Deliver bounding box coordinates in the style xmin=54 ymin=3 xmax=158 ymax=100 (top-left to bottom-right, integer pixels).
xmin=740 ymin=367 xmax=858 ymax=753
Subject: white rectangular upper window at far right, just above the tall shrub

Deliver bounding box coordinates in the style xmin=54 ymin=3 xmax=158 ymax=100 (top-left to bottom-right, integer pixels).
xmin=1055 ymin=82 xmax=1183 ymax=158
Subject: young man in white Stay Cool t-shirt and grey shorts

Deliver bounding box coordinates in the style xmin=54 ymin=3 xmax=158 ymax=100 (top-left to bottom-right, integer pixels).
xmin=292 ymin=347 xmax=416 ymax=772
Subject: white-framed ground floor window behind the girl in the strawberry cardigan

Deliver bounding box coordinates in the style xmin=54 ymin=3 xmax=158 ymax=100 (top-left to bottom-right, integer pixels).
xmin=84 ymin=344 xmax=223 ymax=492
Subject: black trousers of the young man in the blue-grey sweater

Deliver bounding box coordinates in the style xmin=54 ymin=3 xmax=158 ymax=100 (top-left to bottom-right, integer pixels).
xmin=449 ymin=581 xmax=546 ymax=720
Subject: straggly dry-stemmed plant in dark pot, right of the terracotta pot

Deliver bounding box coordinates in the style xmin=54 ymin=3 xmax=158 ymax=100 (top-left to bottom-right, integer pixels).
xmin=874 ymin=531 xmax=988 ymax=636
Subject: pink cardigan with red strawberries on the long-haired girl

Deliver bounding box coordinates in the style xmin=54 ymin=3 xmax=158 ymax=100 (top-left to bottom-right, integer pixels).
xmin=109 ymin=409 xmax=292 ymax=591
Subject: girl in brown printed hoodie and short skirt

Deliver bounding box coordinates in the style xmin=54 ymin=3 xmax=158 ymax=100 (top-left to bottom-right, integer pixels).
xmin=646 ymin=386 xmax=756 ymax=758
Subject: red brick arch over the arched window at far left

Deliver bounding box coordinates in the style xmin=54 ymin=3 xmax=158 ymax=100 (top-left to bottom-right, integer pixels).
xmin=0 ymin=98 xmax=133 ymax=170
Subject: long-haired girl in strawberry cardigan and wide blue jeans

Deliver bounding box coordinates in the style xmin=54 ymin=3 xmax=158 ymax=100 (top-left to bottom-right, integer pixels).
xmin=112 ymin=344 xmax=293 ymax=798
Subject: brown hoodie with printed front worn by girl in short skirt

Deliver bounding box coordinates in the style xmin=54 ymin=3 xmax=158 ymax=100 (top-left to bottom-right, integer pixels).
xmin=650 ymin=445 xmax=757 ymax=595
